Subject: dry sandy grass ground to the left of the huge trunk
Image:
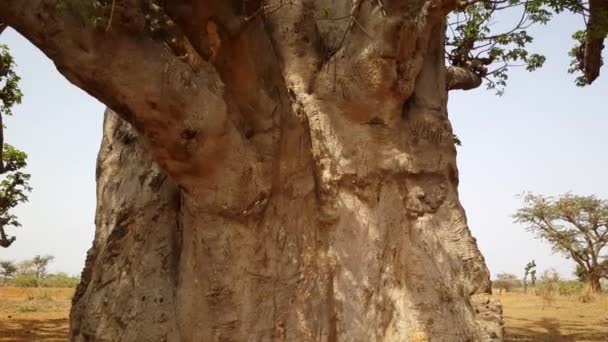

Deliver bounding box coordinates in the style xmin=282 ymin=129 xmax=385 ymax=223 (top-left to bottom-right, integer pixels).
xmin=0 ymin=287 xmax=74 ymax=342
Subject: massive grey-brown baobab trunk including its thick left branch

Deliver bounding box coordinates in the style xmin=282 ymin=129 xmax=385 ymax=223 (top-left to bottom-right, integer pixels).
xmin=0 ymin=0 xmax=502 ymax=342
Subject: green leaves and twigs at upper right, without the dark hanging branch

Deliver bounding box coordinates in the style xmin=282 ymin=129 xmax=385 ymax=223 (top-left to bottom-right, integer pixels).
xmin=446 ymin=0 xmax=608 ymax=95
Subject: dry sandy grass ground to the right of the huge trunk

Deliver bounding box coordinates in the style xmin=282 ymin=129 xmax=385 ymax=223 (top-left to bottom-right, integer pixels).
xmin=499 ymin=293 xmax=608 ymax=342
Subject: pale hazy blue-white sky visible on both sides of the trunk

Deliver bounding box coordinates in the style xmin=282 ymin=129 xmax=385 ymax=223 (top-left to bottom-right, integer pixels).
xmin=0 ymin=16 xmax=608 ymax=276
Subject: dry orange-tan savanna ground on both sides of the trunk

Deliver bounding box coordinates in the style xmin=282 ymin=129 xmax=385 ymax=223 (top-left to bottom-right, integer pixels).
xmin=0 ymin=287 xmax=608 ymax=342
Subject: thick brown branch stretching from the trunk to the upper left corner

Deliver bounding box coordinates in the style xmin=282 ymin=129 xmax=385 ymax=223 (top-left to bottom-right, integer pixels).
xmin=0 ymin=0 xmax=254 ymax=187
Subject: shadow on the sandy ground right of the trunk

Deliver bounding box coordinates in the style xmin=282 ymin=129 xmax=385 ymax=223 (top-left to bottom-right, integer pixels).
xmin=505 ymin=318 xmax=608 ymax=342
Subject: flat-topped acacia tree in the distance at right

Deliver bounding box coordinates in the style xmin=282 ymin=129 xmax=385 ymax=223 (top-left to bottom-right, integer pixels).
xmin=514 ymin=193 xmax=608 ymax=292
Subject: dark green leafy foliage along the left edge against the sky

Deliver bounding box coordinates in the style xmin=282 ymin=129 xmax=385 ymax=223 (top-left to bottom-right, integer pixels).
xmin=0 ymin=42 xmax=31 ymax=247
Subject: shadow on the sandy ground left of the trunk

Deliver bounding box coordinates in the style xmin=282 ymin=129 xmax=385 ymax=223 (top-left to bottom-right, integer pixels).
xmin=0 ymin=318 xmax=69 ymax=342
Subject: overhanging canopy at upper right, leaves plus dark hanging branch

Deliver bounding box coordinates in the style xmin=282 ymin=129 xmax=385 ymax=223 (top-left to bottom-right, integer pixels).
xmin=446 ymin=0 xmax=608 ymax=94
